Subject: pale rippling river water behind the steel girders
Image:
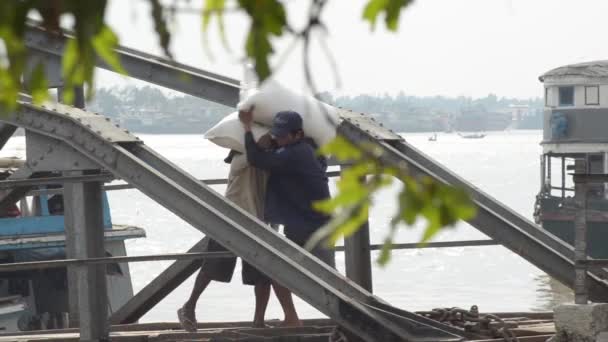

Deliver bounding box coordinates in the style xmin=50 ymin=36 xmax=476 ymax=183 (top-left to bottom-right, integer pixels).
xmin=1 ymin=131 xmax=572 ymax=321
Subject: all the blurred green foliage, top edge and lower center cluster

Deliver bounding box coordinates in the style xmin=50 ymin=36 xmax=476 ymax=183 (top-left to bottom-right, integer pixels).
xmin=0 ymin=0 xmax=475 ymax=264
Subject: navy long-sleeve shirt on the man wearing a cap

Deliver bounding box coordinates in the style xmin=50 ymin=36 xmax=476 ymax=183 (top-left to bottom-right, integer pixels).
xmin=245 ymin=132 xmax=330 ymax=244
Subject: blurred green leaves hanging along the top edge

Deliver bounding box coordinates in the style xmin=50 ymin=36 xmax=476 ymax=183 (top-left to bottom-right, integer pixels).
xmin=0 ymin=0 xmax=412 ymax=109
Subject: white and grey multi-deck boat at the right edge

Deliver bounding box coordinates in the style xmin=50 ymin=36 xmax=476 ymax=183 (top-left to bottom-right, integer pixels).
xmin=534 ymin=61 xmax=608 ymax=258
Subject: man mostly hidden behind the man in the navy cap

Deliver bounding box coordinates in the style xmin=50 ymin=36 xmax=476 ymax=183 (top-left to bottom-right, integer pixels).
xmin=177 ymin=142 xmax=278 ymax=332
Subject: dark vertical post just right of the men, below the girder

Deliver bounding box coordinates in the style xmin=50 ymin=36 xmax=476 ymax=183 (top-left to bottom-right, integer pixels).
xmin=342 ymin=166 xmax=373 ymax=293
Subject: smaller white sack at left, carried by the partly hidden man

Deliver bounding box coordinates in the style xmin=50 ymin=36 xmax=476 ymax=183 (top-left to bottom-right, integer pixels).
xmin=204 ymin=112 xmax=270 ymax=153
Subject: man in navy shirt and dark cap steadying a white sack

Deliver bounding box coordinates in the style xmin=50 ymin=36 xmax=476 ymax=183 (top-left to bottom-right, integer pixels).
xmin=239 ymin=110 xmax=335 ymax=326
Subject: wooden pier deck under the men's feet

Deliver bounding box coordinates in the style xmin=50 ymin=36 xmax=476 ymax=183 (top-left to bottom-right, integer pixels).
xmin=0 ymin=312 xmax=555 ymax=342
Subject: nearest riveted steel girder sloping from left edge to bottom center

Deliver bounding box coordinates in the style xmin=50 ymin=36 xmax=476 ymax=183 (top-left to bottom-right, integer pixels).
xmin=0 ymin=102 xmax=462 ymax=341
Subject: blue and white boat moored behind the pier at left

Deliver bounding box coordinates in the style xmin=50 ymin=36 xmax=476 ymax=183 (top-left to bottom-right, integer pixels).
xmin=0 ymin=159 xmax=146 ymax=333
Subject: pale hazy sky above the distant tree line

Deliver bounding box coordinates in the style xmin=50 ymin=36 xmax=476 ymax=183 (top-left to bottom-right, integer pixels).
xmin=98 ymin=0 xmax=608 ymax=98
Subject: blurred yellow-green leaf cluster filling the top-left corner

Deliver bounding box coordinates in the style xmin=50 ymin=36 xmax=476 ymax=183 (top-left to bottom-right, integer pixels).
xmin=0 ymin=0 xmax=124 ymax=110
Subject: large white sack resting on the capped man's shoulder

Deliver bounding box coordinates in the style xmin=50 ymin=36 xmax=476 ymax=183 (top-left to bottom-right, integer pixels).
xmin=238 ymin=80 xmax=338 ymax=146
